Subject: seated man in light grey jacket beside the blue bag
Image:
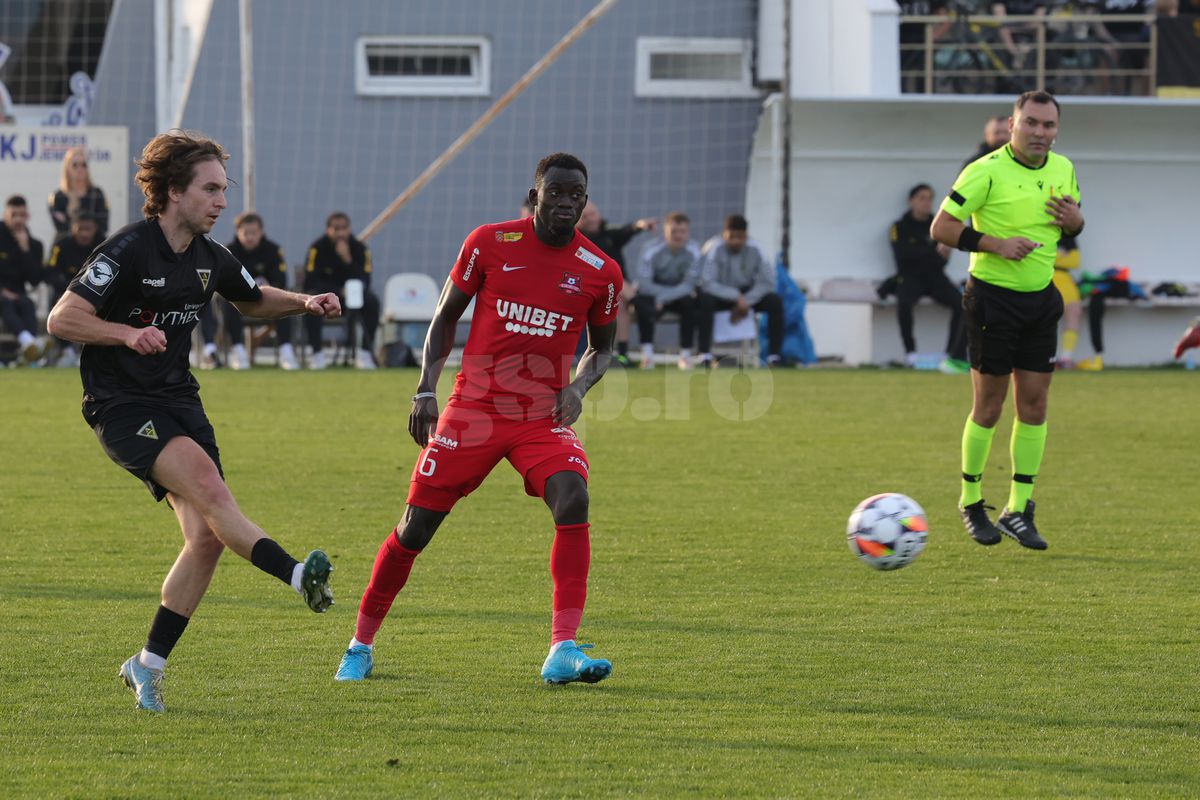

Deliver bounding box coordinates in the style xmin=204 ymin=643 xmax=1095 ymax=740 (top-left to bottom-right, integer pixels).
xmin=696 ymin=213 xmax=784 ymax=367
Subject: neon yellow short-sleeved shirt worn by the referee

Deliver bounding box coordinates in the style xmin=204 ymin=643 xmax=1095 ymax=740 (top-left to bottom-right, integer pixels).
xmin=942 ymin=144 xmax=1080 ymax=291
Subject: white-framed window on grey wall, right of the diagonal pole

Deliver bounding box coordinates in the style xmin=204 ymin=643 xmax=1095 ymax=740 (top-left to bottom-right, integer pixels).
xmin=634 ymin=36 xmax=758 ymax=97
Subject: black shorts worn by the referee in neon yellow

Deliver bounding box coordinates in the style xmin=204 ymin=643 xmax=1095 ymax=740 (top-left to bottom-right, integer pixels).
xmin=962 ymin=276 xmax=1062 ymax=375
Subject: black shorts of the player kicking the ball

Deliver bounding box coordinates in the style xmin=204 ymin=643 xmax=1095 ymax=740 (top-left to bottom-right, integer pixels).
xmin=83 ymin=401 xmax=224 ymax=500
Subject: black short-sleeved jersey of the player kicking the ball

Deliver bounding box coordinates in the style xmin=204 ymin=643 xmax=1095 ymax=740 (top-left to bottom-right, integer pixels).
xmin=68 ymin=219 xmax=263 ymax=402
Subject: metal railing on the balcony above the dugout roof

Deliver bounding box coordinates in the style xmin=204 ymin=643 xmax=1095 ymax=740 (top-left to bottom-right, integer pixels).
xmin=900 ymin=12 xmax=1158 ymax=95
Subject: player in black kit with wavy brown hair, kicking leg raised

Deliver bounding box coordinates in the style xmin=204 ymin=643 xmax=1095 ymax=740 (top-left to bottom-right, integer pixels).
xmin=48 ymin=131 xmax=341 ymax=711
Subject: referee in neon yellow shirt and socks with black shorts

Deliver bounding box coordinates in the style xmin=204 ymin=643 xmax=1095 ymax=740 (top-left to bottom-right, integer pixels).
xmin=930 ymin=91 xmax=1084 ymax=551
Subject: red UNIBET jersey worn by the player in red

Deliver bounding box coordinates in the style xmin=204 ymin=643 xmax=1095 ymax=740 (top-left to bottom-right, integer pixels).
xmin=450 ymin=217 xmax=622 ymax=419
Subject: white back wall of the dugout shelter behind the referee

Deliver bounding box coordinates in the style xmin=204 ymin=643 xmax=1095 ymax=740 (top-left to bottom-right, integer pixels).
xmin=746 ymin=96 xmax=1200 ymax=362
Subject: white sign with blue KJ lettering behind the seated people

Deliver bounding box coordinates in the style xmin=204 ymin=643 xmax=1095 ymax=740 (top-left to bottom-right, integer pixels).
xmin=0 ymin=126 xmax=131 ymax=252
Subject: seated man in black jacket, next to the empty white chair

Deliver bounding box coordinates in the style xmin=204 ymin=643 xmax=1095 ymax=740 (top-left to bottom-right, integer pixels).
xmin=304 ymin=211 xmax=379 ymax=369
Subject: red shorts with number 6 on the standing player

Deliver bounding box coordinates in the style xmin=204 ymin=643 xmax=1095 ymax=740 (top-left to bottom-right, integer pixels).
xmin=408 ymin=403 xmax=588 ymax=511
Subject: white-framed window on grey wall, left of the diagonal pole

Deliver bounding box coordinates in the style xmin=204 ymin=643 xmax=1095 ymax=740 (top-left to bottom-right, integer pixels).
xmin=354 ymin=36 xmax=491 ymax=97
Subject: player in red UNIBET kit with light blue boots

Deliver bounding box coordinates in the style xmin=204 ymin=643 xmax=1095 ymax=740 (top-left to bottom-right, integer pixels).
xmin=336 ymin=152 xmax=622 ymax=684
